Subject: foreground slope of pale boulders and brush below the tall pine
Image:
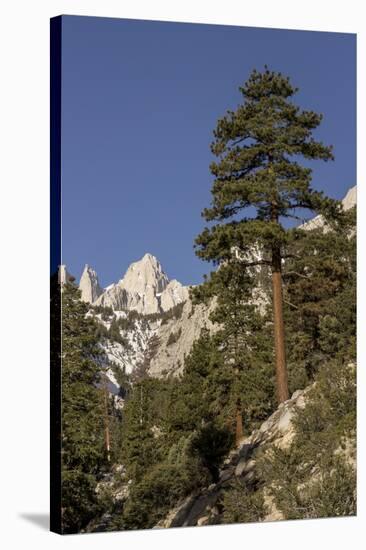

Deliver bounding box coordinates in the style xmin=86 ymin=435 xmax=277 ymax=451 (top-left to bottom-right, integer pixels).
xmin=88 ymin=363 xmax=356 ymax=531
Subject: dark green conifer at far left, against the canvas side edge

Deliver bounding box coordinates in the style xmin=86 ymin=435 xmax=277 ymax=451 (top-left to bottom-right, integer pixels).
xmin=61 ymin=284 xmax=106 ymax=533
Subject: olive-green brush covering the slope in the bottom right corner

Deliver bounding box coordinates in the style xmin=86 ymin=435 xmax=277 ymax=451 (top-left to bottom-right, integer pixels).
xmin=259 ymin=362 xmax=356 ymax=519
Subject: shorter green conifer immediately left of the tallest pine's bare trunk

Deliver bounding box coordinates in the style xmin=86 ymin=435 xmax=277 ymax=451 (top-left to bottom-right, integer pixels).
xmin=192 ymin=258 xmax=273 ymax=445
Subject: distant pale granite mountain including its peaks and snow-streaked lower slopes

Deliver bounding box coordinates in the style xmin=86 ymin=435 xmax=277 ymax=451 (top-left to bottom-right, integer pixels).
xmin=79 ymin=254 xmax=212 ymax=385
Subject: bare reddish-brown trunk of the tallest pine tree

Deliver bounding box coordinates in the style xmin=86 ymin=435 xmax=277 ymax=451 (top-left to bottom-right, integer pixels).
xmin=272 ymin=246 xmax=289 ymax=403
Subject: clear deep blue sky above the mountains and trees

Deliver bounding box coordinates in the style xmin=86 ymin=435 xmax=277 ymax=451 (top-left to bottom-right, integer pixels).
xmin=62 ymin=16 xmax=356 ymax=286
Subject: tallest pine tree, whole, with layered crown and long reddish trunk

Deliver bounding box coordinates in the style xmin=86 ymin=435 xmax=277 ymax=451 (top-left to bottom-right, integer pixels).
xmin=196 ymin=68 xmax=339 ymax=402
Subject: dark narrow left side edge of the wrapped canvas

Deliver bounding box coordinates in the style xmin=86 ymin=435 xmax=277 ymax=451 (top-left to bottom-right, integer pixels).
xmin=50 ymin=16 xmax=62 ymax=534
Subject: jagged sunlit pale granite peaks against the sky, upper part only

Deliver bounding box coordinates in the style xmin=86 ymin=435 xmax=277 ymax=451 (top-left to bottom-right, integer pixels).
xmin=79 ymin=253 xmax=188 ymax=315
